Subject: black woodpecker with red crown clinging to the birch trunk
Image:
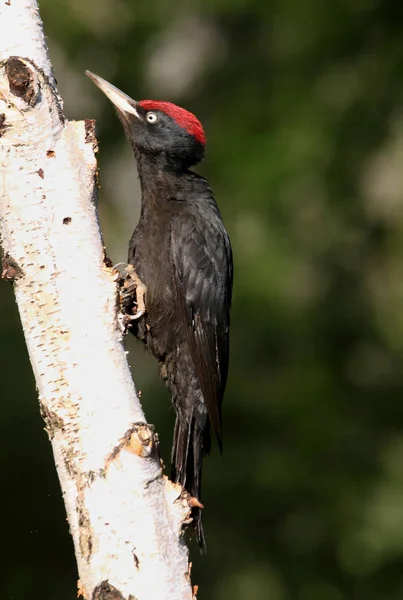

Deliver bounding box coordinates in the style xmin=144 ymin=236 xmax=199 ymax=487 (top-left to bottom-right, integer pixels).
xmin=86 ymin=71 xmax=233 ymax=552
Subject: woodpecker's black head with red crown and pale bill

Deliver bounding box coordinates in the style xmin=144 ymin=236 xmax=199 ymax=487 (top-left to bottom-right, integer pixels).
xmin=86 ymin=71 xmax=206 ymax=170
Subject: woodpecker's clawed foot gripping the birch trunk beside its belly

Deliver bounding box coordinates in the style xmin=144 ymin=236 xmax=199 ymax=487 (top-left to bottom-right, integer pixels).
xmin=113 ymin=263 xmax=147 ymax=333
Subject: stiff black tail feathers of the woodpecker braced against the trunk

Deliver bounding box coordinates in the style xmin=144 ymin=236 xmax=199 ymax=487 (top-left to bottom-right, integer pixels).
xmin=171 ymin=414 xmax=210 ymax=552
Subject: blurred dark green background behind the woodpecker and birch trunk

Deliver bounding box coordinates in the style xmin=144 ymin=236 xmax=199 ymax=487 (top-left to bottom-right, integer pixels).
xmin=0 ymin=0 xmax=403 ymax=600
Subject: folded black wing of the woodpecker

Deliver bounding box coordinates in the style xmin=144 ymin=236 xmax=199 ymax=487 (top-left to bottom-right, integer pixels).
xmin=171 ymin=199 xmax=233 ymax=448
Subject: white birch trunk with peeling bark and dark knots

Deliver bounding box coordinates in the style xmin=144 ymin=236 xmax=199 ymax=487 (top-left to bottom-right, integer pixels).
xmin=0 ymin=0 xmax=196 ymax=600
